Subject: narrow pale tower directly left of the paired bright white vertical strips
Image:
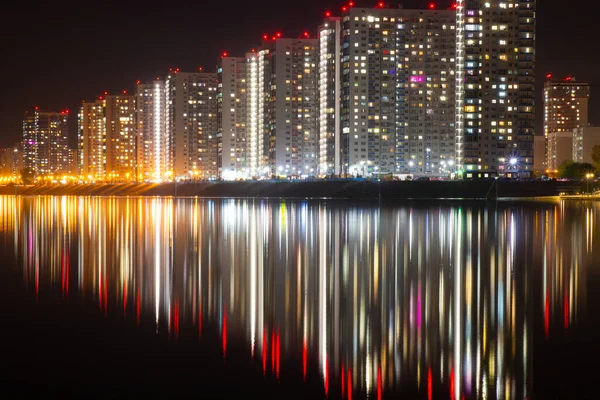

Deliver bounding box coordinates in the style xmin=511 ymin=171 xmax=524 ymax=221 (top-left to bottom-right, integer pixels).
xmin=217 ymin=56 xmax=250 ymax=180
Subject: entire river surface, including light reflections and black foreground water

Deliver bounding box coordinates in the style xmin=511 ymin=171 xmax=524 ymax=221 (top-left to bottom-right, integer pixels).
xmin=0 ymin=196 xmax=600 ymax=399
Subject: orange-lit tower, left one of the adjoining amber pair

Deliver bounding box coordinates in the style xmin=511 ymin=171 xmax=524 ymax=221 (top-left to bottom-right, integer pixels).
xmin=77 ymin=97 xmax=106 ymax=180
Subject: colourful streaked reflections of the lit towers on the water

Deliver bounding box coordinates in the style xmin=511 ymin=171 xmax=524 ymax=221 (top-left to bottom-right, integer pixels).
xmin=0 ymin=197 xmax=599 ymax=399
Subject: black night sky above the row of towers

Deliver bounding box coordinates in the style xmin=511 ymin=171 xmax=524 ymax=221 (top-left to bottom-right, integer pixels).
xmin=0 ymin=0 xmax=600 ymax=147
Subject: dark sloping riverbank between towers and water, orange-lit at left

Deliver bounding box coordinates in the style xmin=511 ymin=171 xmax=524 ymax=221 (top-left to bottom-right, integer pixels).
xmin=0 ymin=179 xmax=572 ymax=200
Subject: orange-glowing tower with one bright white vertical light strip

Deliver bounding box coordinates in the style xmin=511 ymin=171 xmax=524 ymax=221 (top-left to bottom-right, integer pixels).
xmin=136 ymin=80 xmax=169 ymax=181
